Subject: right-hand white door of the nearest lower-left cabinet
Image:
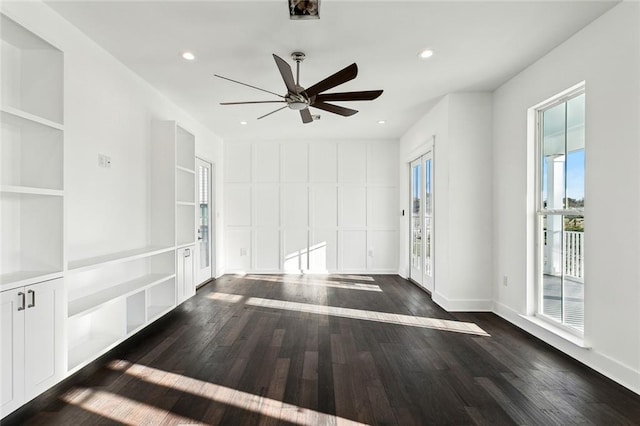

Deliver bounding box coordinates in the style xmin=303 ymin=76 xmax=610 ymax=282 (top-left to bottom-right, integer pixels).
xmin=24 ymin=279 xmax=65 ymax=399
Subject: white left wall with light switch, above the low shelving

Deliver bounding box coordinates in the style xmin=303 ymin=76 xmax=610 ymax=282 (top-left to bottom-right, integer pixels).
xmin=2 ymin=2 xmax=222 ymax=276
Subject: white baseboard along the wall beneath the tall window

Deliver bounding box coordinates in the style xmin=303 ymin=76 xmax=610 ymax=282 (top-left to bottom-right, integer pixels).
xmin=493 ymin=302 xmax=640 ymax=395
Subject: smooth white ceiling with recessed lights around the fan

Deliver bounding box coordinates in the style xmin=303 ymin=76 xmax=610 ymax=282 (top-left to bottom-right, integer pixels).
xmin=47 ymin=0 xmax=616 ymax=139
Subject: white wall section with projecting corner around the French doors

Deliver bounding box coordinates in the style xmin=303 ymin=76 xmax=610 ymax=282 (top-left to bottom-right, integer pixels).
xmin=399 ymin=93 xmax=492 ymax=311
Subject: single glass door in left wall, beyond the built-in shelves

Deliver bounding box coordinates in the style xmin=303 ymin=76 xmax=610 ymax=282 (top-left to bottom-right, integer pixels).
xmin=195 ymin=158 xmax=213 ymax=285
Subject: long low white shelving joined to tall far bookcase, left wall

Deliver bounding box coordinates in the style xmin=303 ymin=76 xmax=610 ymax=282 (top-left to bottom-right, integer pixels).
xmin=66 ymin=121 xmax=196 ymax=372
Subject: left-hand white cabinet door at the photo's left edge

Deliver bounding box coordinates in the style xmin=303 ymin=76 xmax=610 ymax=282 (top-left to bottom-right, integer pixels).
xmin=0 ymin=288 xmax=26 ymax=418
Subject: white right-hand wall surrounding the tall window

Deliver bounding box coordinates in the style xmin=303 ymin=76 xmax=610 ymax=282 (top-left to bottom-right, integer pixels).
xmin=492 ymin=2 xmax=640 ymax=393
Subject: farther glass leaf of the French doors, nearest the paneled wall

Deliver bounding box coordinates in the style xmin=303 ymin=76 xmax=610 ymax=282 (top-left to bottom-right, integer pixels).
xmin=409 ymin=158 xmax=424 ymax=285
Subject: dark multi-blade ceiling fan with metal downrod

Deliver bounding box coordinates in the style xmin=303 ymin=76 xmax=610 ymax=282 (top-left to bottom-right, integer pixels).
xmin=214 ymin=52 xmax=382 ymax=123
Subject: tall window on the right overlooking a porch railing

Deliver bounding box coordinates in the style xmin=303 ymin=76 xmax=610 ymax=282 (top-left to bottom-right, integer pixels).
xmin=536 ymin=86 xmax=585 ymax=334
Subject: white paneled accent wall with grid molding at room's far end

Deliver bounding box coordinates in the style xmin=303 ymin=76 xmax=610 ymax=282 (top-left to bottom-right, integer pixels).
xmin=224 ymin=141 xmax=400 ymax=273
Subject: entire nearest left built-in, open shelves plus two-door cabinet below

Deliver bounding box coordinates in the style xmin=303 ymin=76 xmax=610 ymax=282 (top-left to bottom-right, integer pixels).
xmin=0 ymin=14 xmax=66 ymax=417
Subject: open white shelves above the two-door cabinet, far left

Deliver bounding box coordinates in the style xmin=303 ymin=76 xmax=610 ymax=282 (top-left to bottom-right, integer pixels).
xmin=0 ymin=15 xmax=64 ymax=290
